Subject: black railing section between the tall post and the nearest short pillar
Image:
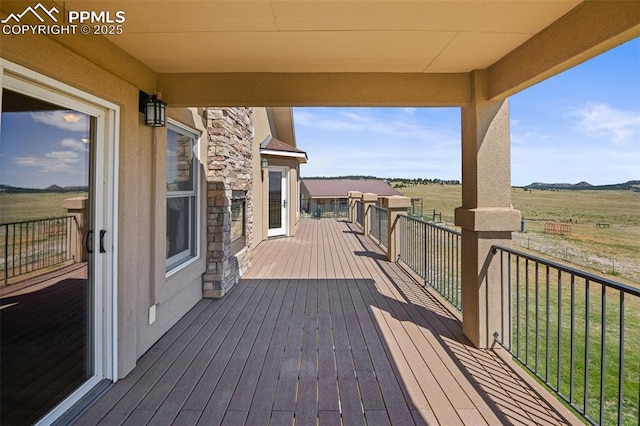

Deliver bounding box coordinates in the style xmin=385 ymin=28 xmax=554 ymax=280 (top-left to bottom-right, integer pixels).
xmin=397 ymin=215 xmax=462 ymax=310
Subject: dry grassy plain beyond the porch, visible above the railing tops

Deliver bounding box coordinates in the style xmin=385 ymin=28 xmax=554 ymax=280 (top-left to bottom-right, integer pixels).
xmin=400 ymin=185 xmax=640 ymax=287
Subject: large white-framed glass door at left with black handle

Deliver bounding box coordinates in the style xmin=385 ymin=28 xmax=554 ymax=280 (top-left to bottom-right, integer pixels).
xmin=0 ymin=76 xmax=112 ymax=424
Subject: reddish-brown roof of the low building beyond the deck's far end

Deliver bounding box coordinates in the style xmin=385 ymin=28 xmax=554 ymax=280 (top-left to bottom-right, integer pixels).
xmin=302 ymin=179 xmax=402 ymax=198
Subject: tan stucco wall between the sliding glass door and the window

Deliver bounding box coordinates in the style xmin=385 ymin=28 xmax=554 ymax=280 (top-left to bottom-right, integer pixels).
xmin=0 ymin=35 xmax=206 ymax=377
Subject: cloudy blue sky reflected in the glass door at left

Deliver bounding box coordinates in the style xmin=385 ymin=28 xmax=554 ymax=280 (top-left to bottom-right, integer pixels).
xmin=0 ymin=105 xmax=90 ymax=188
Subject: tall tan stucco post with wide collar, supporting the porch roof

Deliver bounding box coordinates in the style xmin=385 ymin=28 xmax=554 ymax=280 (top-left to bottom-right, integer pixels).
xmin=455 ymin=71 xmax=520 ymax=348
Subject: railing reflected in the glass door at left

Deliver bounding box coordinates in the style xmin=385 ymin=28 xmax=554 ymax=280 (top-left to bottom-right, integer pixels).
xmin=0 ymin=216 xmax=79 ymax=284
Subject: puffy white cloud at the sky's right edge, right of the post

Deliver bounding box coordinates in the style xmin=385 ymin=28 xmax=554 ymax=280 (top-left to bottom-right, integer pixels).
xmin=566 ymin=103 xmax=640 ymax=143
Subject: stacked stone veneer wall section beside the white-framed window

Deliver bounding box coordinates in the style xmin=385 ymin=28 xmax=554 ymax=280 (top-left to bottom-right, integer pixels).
xmin=203 ymin=108 xmax=253 ymax=297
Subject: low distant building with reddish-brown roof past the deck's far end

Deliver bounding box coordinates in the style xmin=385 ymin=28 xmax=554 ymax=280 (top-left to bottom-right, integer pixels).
xmin=300 ymin=179 xmax=402 ymax=217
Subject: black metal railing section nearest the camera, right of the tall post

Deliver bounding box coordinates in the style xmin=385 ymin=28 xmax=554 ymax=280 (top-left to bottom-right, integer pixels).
xmin=493 ymin=247 xmax=640 ymax=425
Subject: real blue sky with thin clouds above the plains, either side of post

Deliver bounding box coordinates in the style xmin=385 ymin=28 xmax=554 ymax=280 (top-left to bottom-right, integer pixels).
xmin=294 ymin=39 xmax=640 ymax=185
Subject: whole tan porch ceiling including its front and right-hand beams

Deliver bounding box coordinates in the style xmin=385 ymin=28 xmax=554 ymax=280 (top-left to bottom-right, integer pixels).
xmin=0 ymin=0 xmax=640 ymax=107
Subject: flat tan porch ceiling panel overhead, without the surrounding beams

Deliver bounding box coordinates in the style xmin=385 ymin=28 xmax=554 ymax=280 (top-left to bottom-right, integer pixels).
xmin=101 ymin=0 xmax=581 ymax=73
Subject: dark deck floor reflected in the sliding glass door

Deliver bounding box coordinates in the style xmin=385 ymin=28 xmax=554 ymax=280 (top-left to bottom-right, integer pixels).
xmin=0 ymin=263 xmax=87 ymax=425
